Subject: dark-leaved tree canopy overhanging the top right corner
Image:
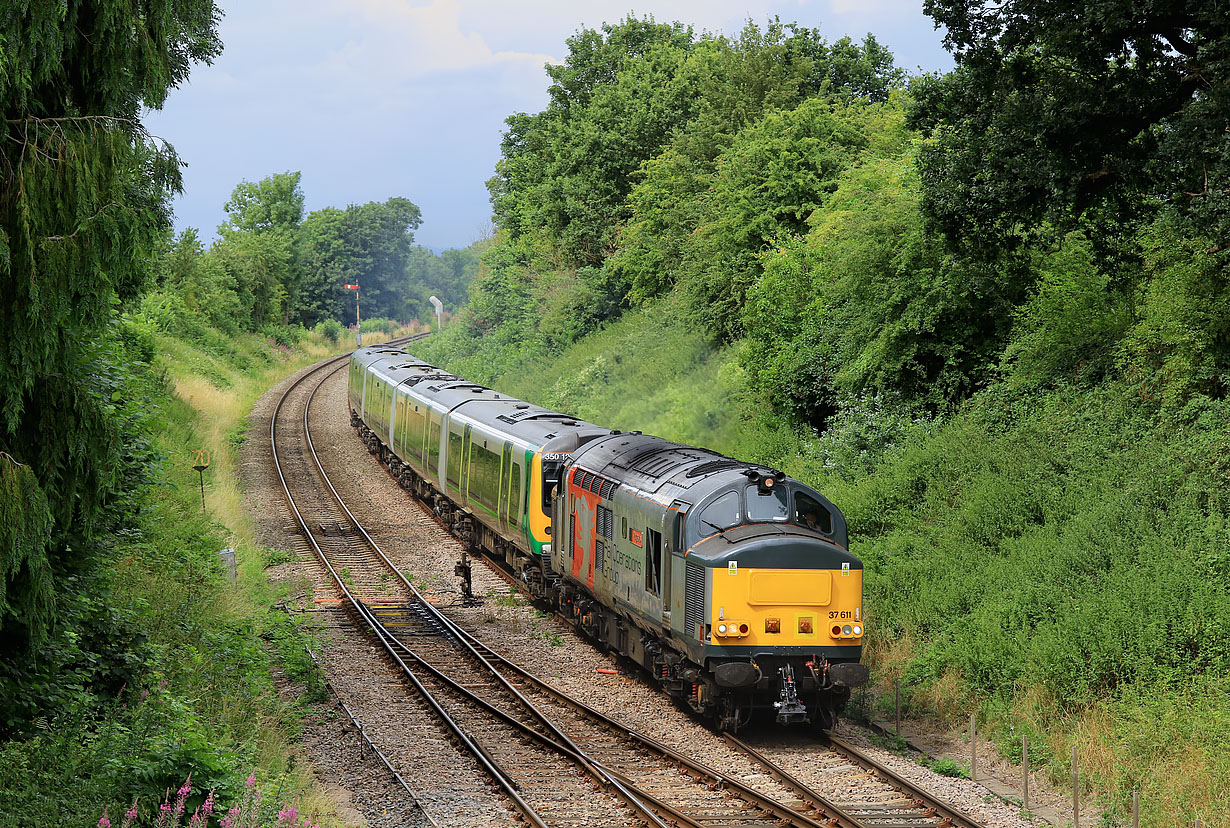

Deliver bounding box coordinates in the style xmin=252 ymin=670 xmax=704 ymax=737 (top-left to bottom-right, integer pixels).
xmin=914 ymin=0 xmax=1230 ymax=250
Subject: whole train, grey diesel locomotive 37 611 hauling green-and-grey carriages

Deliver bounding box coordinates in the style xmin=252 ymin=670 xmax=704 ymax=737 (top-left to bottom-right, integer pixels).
xmin=348 ymin=346 xmax=867 ymax=731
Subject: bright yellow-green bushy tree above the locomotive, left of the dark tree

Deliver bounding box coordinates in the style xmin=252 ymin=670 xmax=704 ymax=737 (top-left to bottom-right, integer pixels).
xmin=744 ymin=137 xmax=1021 ymax=428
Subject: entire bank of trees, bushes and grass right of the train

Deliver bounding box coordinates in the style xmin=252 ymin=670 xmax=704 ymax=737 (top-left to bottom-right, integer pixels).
xmin=418 ymin=11 xmax=1230 ymax=824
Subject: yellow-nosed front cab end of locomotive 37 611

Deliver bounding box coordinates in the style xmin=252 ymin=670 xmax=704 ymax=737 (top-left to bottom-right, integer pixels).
xmin=684 ymin=480 xmax=867 ymax=730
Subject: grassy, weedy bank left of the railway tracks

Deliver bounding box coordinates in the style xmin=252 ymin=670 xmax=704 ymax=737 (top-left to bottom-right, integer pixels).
xmin=0 ymin=331 xmax=413 ymax=828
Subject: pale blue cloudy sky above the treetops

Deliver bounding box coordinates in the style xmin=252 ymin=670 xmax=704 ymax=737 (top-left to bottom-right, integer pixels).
xmin=146 ymin=0 xmax=952 ymax=247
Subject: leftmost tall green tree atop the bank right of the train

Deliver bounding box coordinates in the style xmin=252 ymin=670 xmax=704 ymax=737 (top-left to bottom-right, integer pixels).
xmin=487 ymin=17 xmax=695 ymax=267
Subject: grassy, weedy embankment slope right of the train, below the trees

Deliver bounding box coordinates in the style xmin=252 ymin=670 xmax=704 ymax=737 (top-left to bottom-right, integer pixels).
xmin=422 ymin=309 xmax=1230 ymax=826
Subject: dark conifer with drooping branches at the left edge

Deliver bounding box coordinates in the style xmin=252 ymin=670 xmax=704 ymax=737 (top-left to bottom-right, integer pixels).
xmin=0 ymin=0 xmax=220 ymax=642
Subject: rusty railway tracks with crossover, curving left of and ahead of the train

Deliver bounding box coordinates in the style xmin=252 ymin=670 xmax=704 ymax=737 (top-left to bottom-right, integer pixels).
xmin=269 ymin=337 xmax=979 ymax=828
